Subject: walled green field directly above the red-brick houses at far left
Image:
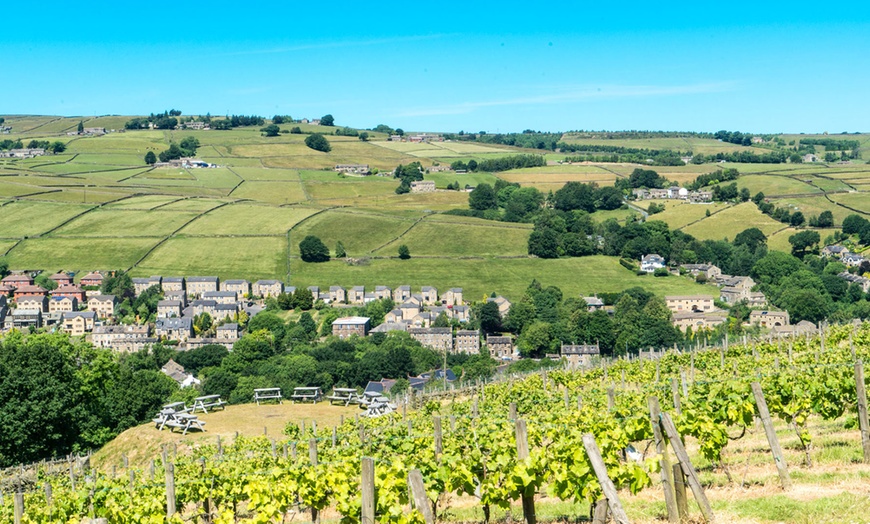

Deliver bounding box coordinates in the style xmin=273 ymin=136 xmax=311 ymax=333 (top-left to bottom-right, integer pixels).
xmin=6 ymin=237 xmax=158 ymax=271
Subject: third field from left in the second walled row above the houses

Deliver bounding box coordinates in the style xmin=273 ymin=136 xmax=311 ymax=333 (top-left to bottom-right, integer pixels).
xmin=181 ymin=204 xmax=317 ymax=236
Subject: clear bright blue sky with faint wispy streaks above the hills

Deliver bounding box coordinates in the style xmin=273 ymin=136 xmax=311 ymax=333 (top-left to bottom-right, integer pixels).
xmin=0 ymin=0 xmax=870 ymax=133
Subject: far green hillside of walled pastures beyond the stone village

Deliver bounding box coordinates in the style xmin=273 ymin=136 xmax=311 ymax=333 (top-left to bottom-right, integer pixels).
xmin=0 ymin=116 xmax=870 ymax=296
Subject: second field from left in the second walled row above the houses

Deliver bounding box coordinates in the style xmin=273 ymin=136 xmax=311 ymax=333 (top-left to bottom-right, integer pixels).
xmin=52 ymin=209 xmax=196 ymax=237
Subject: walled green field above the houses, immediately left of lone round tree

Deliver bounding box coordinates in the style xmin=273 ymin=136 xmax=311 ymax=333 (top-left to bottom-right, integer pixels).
xmin=133 ymin=236 xmax=287 ymax=280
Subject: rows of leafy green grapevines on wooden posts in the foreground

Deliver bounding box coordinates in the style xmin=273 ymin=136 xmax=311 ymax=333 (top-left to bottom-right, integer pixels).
xmin=0 ymin=326 xmax=870 ymax=524
